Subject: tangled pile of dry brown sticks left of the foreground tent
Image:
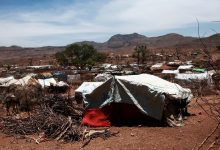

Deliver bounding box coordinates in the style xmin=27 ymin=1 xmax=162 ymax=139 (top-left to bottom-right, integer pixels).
xmin=1 ymin=95 xmax=117 ymax=146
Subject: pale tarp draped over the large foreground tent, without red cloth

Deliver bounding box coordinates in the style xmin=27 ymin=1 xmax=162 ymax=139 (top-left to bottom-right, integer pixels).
xmin=84 ymin=74 xmax=192 ymax=120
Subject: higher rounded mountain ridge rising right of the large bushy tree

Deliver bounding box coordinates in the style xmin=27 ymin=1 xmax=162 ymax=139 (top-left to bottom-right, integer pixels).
xmin=75 ymin=33 xmax=220 ymax=51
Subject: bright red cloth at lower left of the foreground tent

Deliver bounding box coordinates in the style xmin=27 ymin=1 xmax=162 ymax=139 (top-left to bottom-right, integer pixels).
xmin=82 ymin=108 xmax=111 ymax=127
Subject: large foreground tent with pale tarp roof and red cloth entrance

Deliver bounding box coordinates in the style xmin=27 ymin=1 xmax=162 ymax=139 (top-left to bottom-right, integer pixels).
xmin=82 ymin=74 xmax=192 ymax=126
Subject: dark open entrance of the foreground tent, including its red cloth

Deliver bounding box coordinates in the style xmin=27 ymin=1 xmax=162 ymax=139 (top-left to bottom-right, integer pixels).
xmin=82 ymin=103 xmax=161 ymax=127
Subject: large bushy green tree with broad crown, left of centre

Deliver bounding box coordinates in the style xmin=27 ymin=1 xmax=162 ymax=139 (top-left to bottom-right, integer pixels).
xmin=56 ymin=44 xmax=106 ymax=69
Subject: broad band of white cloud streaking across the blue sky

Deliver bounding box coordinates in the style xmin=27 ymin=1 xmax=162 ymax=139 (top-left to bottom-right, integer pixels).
xmin=0 ymin=0 xmax=220 ymax=46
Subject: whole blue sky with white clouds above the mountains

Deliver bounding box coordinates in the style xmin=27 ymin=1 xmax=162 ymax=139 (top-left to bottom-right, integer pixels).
xmin=0 ymin=0 xmax=220 ymax=47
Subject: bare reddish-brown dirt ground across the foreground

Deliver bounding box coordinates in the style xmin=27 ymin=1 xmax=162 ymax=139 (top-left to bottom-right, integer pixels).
xmin=0 ymin=96 xmax=220 ymax=150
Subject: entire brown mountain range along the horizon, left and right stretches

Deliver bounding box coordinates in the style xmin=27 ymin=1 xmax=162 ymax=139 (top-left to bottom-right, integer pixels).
xmin=0 ymin=33 xmax=220 ymax=60
